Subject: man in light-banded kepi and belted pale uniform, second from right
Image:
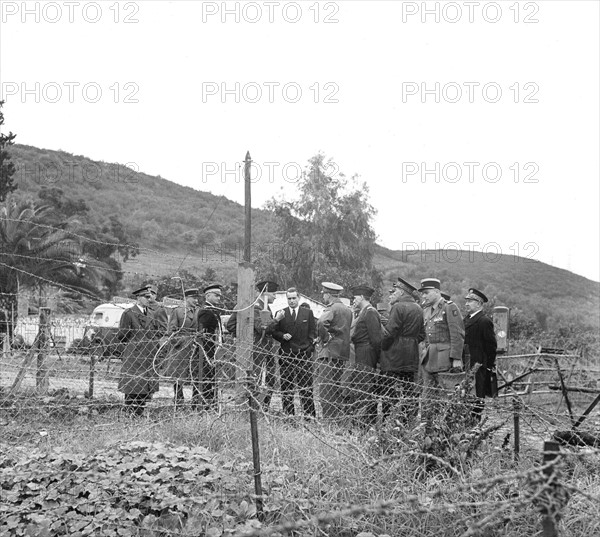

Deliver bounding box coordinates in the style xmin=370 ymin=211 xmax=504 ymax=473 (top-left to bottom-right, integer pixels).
xmin=419 ymin=278 xmax=465 ymax=417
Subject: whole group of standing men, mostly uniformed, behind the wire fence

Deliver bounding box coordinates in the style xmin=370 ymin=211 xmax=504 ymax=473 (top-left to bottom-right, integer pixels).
xmin=113 ymin=278 xmax=496 ymax=425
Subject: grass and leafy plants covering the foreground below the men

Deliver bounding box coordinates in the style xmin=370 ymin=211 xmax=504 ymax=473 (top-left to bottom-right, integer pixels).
xmin=0 ymin=393 xmax=600 ymax=537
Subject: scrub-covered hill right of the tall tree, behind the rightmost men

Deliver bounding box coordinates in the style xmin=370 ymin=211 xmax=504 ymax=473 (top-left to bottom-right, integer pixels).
xmin=375 ymin=247 xmax=600 ymax=329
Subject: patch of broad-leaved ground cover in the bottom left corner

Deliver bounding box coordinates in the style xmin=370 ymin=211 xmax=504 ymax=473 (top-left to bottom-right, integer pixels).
xmin=0 ymin=442 xmax=264 ymax=536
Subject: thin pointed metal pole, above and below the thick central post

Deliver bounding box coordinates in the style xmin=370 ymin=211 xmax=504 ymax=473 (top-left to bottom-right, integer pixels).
xmin=244 ymin=151 xmax=264 ymax=521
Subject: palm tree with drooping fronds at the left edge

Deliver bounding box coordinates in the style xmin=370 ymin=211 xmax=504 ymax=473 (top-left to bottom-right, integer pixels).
xmin=0 ymin=200 xmax=115 ymax=338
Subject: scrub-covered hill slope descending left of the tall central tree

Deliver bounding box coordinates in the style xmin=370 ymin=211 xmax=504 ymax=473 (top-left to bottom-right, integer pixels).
xmin=11 ymin=145 xmax=272 ymax=252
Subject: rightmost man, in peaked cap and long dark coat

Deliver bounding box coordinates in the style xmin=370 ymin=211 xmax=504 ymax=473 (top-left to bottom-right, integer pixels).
xmin=463 ymin=288 xmax=498 ymax=419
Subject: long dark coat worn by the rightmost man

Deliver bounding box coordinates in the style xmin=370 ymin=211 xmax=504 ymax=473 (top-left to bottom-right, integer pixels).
xmin=463 ymin=310 xmax=497 ymax=397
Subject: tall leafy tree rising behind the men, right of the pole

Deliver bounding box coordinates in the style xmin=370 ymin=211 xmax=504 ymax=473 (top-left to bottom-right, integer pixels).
xmin=256 ymin=154 xmax=382 ymax=296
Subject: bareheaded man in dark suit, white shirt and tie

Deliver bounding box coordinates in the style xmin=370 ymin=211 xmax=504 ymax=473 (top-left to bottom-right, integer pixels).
xmin=273 ymin=287 xmax=317 ymax=418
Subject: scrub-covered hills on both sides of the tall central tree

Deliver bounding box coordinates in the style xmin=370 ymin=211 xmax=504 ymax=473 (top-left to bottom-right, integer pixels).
xmin=11 ymin=145 xmax=600 ymax=329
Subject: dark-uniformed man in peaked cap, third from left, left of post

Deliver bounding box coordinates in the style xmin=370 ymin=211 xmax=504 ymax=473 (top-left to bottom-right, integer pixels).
xmin=193 ymin=283 xmax=223 ymax=408
